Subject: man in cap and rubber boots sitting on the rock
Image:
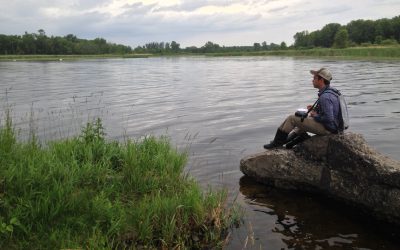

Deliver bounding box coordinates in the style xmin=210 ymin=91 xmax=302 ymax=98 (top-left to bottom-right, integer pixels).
xmin=264 ymin=68 xmax=341 ymax=149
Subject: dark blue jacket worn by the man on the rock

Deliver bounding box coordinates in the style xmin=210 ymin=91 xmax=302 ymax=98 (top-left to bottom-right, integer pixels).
xmin=314 ymin=87 xmax=341 ymax=133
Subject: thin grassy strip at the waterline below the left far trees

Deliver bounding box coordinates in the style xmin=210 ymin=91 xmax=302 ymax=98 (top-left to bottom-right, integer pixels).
xmin=0 ymin=54 xmax=152 ymax=61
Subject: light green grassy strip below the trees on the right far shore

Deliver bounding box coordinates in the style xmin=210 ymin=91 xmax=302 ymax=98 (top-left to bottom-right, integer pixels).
xmin=207 ymin=46 xmax=400 ymax=60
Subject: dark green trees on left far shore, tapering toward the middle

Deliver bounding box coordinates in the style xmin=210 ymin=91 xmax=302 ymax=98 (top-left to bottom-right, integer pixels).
xmin=0 ymin=29 xmax=132 ymax=55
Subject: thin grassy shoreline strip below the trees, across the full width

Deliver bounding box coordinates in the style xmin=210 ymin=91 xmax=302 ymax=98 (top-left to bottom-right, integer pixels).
xmin=0 ymin=46 xmax=400 ymax=61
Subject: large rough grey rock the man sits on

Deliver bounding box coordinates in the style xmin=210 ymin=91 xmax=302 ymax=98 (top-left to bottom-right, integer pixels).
xmin=240 ymin=133 xmax=400 ymax=225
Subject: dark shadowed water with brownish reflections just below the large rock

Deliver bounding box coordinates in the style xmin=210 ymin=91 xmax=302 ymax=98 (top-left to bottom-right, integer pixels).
xmin=235 ymin=176 xmax=400 ymax=249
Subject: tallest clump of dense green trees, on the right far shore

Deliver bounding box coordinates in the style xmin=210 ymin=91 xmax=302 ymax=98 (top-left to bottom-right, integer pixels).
xmin=294 ymin=16 xmax=400 ymax=48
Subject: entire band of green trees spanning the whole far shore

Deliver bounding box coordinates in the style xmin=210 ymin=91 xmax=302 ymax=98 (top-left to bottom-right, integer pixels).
xmin=0 ymin=16 xmax=400 ymax=55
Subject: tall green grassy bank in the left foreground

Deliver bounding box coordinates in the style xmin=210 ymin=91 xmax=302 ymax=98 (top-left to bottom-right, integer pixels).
xmin=0 ymin=114 xmax=237 ymax=249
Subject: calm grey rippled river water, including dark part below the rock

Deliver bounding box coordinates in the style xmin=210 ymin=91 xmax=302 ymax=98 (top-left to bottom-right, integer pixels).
xmin=0 ymin=57 xmax=400 ymax=249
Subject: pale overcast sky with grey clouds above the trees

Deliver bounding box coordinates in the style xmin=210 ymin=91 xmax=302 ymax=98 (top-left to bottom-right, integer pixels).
xmin=0 ymin=0 xmax=400 ymax=48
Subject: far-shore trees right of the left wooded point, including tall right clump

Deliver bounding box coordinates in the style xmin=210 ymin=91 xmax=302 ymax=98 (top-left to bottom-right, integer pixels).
xmin=134 ymin=16 xmax=400 ymax=54
